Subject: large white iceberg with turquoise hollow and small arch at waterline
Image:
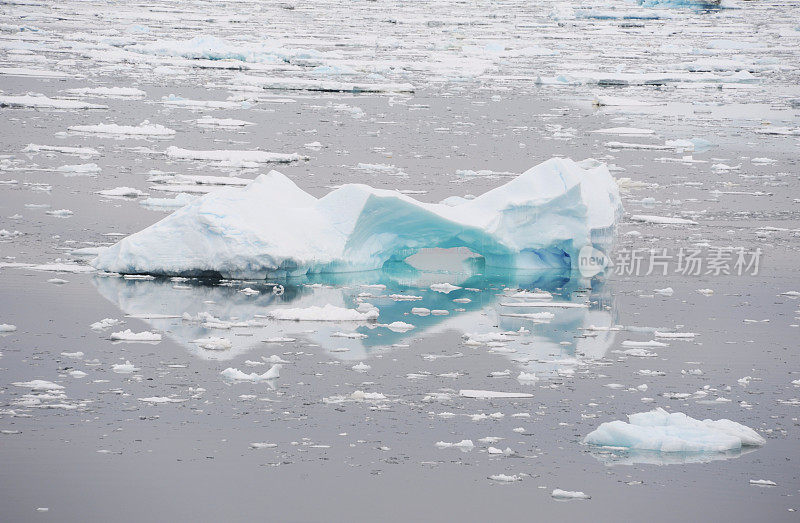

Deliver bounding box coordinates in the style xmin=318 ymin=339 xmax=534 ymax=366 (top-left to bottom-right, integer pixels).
xmin=92 ymin=158 xmax=622 ymax=278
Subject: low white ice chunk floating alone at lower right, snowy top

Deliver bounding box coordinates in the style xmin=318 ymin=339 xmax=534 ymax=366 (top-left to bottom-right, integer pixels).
xmin=584 ymin=408 xmax=766 ymax=452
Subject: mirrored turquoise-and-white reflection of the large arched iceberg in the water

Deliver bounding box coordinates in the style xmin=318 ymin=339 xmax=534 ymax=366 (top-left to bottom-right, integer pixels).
xmin=93 ymin=263 xmax=615 ymax=376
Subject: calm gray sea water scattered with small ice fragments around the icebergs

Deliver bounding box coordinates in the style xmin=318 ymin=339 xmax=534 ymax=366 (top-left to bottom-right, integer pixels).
xmin=0 ymin=0 xmax=800 ymax=521
